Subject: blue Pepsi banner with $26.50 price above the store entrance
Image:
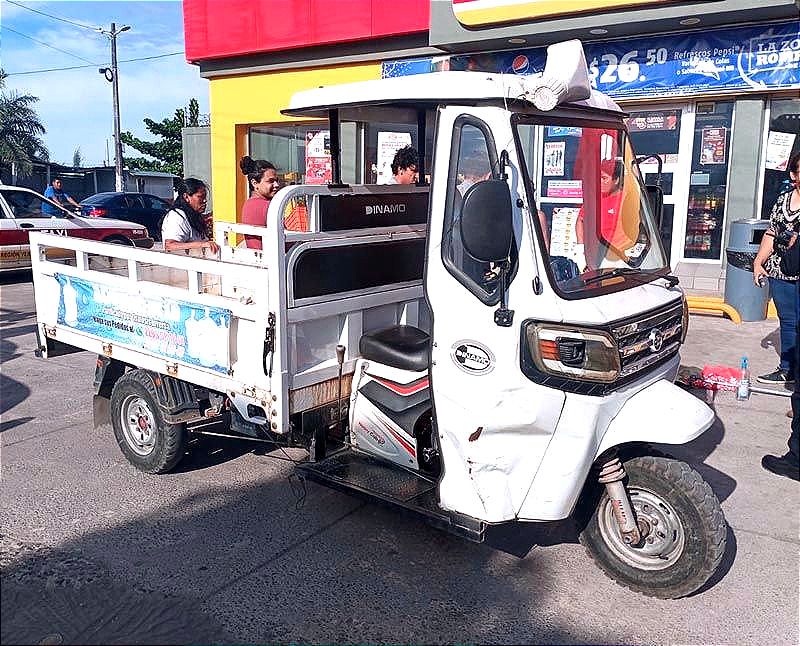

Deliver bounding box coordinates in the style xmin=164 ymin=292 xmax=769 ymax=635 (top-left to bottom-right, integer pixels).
xmin=384 ymin=22 xmax=800 ymax=99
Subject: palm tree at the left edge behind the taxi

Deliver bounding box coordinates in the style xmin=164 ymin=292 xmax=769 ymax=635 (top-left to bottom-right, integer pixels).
xmin=0 ymin=69 xmax=49 ymax=176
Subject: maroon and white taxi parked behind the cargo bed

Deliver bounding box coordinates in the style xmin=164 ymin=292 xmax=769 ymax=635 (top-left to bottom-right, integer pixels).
xmin=0 ymin=184 xmax=153 ymax=271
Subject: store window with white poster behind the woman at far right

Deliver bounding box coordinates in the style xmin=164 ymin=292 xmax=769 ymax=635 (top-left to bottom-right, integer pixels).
xmin=761 ymin=99 xmax=800 ymax=218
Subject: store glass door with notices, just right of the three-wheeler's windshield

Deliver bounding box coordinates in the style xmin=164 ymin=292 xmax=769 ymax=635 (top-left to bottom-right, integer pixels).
xmin=627 ymin=106 xmax=683 ymax=266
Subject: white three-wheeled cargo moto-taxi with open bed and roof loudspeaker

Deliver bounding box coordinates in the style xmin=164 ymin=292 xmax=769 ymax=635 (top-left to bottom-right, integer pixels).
xmin=31 ymin=41 xmax=726 ymax=598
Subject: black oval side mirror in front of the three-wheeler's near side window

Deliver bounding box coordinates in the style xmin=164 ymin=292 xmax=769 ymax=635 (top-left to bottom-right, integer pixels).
xmin=461 ymin=179 xmax=514 ymax=263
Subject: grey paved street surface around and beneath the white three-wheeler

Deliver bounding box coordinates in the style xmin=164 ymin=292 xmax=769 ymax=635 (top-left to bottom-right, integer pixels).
xmin=0 ymin=274 xmax=800 ymax=644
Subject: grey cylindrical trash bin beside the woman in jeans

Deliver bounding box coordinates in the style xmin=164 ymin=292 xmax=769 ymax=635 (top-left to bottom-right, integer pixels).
xmin=725 ymin=219 xmax=769 ymax=321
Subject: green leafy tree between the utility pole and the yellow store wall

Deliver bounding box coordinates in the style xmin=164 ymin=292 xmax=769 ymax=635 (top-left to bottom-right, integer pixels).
xmin=120 ymin=99 xmax=200 ymax=177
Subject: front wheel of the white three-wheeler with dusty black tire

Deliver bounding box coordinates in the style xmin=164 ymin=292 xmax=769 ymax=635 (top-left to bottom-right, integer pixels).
xmin=580 ymin=456 xmax=727 ymax=599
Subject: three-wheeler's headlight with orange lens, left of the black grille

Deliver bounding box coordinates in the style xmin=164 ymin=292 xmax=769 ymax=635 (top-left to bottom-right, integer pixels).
xmin=525 ymin=323 xmax=620 ymax=383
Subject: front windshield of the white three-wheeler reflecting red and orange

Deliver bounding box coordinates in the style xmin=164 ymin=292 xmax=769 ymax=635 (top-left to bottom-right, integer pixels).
xmin=515 ymin=117 xmax=667 ymax=297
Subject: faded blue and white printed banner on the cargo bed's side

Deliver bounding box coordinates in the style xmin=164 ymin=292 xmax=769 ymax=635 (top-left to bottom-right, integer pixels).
xmin=56 ymin=274 xmax=231 ymax=374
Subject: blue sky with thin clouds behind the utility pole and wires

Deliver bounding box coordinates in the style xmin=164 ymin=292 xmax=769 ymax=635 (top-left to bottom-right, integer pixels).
xmin=0 ymin=0 xmax=209 ymax=166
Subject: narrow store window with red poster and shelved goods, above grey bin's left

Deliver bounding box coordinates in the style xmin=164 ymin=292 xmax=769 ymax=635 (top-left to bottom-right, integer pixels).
xmin=683 ymin=101 xmax=733 ymax=260
